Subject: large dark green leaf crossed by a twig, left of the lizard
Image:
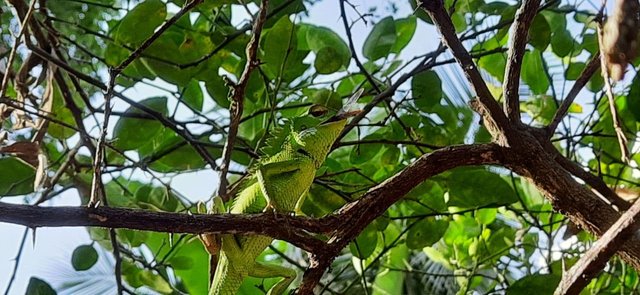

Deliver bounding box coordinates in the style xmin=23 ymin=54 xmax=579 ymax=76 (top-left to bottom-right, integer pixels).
xmin=113 ymin=97 xmax=168 ymax=150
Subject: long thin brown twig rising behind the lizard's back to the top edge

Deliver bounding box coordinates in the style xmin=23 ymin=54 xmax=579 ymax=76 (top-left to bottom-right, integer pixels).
xmin=218 ymin=0 xmax=269 ymax=201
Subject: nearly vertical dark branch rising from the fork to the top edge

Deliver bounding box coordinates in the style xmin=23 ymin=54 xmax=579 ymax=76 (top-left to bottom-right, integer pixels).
xmin=503 ymin=0 xmax=540 ymax=123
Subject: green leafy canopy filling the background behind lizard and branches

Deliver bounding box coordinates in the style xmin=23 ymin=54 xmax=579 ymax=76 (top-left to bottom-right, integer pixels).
xmin=0 ymin=0 xmax=640 ymax=294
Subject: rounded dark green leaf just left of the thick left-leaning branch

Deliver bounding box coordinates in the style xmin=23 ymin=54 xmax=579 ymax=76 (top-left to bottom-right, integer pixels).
xmin=411 ymin=71 xmax=443 ymax=113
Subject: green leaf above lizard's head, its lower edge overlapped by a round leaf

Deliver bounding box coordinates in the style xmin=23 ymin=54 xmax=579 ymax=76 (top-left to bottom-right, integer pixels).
xmin=306 ymin=26 xmax=351 ymax=73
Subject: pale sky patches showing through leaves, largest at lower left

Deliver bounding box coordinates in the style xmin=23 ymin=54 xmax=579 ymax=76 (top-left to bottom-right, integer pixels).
xmin=0 ymin=0 xmax=430 ymax=294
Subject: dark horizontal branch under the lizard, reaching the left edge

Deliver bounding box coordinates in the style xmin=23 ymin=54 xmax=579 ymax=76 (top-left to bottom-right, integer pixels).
xmin=0 ymin=202 xmax=325 ymax=252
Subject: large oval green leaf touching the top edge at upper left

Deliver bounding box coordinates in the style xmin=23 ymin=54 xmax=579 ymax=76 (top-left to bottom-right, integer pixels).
xmin=115 ymin=0 xmax=167 ymax=45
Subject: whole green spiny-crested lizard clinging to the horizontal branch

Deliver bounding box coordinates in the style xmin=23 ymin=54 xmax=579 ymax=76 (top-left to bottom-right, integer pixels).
xmin=201 ymin=90 xmax=362 ymax=295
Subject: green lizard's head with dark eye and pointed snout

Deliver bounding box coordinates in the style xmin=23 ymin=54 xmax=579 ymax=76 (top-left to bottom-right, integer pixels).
xmin=292 ymin=89 xmax=363 ymax=168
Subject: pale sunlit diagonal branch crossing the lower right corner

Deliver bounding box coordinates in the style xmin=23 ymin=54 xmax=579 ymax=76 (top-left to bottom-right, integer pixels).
xmin=554 ymin=202 xmax=640 ymax=294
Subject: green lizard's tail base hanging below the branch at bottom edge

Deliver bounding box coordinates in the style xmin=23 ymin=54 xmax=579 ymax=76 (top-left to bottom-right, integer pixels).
xmin=209 ymin=254 xmax=245 ymax=295
